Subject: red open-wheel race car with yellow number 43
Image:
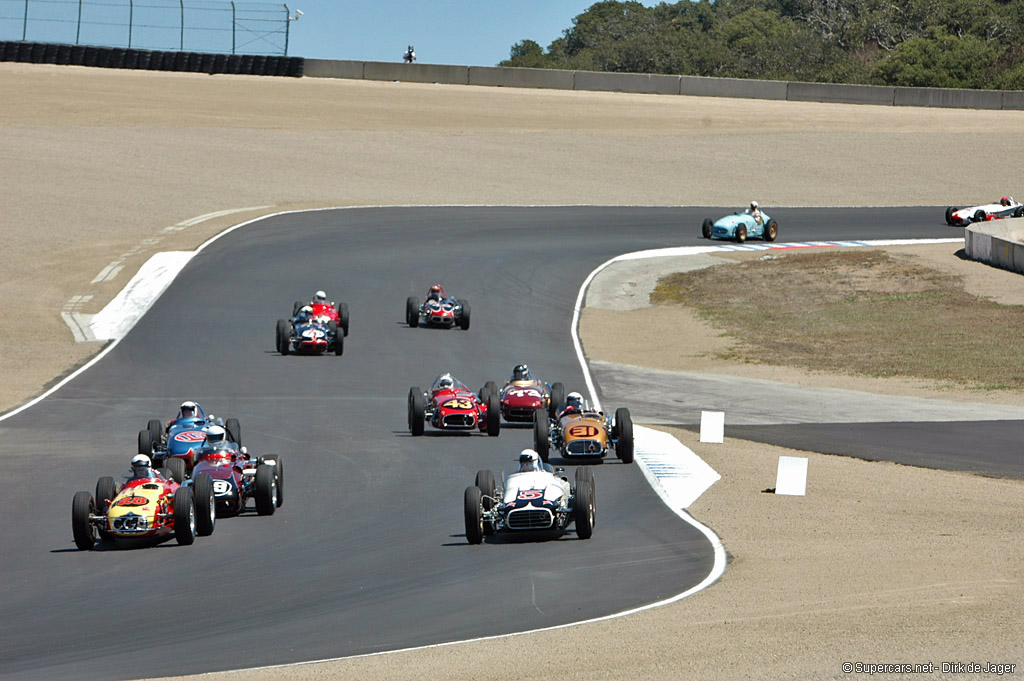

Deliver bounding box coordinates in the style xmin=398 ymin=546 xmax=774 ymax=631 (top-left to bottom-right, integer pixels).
xmin=409 ymin=374 xmax=502 ymax=436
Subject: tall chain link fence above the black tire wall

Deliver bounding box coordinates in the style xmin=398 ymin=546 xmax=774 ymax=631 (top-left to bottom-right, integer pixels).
xmin=0 ymin=0 xmax=297 ymax=55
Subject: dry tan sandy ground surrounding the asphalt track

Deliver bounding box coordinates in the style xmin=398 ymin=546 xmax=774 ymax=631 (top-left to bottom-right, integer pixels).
xmin=0 ymin=63 xmax=1024 ymax=680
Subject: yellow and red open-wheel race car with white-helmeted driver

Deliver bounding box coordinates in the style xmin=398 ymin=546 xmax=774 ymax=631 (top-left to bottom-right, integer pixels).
xmin=71 ymin=454 xmax=217 ymax=551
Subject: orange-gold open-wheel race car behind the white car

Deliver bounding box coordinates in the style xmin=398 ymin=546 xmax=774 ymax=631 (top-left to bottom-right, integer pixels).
xmin=534 ymin=392 xmax=633 ymax=464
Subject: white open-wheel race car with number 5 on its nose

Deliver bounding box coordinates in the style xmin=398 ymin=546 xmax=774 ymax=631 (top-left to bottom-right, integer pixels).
xmin=464 ymin=450 xmax=594 ymax=544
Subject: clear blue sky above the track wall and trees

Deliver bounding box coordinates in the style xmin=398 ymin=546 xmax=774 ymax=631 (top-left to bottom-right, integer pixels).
xmin=0 ymin=0 xmax=654 ymax=66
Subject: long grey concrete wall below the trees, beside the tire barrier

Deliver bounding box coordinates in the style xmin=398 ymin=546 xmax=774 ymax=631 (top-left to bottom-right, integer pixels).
xmin=305 ymin=59 xmax=1024 ymax=111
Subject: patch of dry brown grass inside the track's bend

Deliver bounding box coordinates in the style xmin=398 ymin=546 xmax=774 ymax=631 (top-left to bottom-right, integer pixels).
xmin=651 ymin=249 xmax=1024 ymax=390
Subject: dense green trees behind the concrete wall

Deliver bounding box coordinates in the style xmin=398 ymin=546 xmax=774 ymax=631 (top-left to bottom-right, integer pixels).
xmin=499 ymin=0 xmax=1024 ymax=90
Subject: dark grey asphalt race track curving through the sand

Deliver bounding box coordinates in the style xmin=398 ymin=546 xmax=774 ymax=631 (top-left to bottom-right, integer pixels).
xmin=0 ymin=207 xmax=977 ymax=680
